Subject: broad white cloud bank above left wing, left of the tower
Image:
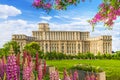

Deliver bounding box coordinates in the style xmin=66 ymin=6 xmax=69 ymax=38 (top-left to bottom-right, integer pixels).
xmin=0 ymin=19 xmax=37 ymax=47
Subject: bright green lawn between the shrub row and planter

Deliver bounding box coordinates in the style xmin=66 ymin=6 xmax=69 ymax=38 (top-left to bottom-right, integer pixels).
xmin=47 ymin=60 xmax=120 ymax=80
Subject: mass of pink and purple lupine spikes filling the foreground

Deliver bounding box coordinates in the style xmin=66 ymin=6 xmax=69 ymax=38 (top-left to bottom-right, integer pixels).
xmin=0 ymin=53 xmax=99 ymax=80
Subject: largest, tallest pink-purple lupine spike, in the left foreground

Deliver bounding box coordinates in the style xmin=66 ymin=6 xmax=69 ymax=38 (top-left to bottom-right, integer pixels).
xmin=6 ymin=54 xmax=19 ymax=80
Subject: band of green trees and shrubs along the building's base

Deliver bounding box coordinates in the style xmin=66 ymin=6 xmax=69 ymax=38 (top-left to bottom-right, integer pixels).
xmin=0 ymin=41 xmax=120 ymax=60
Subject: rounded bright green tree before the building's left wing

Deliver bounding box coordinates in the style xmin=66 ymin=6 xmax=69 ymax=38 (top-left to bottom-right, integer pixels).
xmin=24 ymin=42 xmax=40 ymax=56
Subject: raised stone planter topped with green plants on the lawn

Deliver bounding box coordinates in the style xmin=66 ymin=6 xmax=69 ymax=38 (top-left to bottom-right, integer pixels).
xmin=71 ymin=64 xmax=106 ymax=80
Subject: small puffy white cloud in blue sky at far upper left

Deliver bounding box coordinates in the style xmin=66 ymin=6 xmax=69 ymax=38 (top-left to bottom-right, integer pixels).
xmin=0 ymin=5 xmax=22 ymax=19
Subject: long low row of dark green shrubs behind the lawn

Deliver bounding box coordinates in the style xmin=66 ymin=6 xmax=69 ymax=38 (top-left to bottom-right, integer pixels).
xmin=39 ymin=51 xmax=120 ymax=60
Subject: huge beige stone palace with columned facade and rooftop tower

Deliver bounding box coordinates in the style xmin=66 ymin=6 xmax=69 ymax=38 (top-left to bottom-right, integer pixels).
xmin=12 ymin=23 xmax=112 ymax=55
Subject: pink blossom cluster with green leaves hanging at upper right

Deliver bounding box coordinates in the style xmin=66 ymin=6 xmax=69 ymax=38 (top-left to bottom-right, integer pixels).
xmin=89 ymin=3 xmax=120 ymax=28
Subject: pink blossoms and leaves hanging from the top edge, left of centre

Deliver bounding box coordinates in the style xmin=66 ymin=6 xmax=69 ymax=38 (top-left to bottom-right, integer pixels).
xmin=33 ymin=0 xmax=85 ymax=11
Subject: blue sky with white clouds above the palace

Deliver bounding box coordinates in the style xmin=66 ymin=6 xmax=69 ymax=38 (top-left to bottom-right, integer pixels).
xmin=0 ymin=0 xmax=120 ymax=51
